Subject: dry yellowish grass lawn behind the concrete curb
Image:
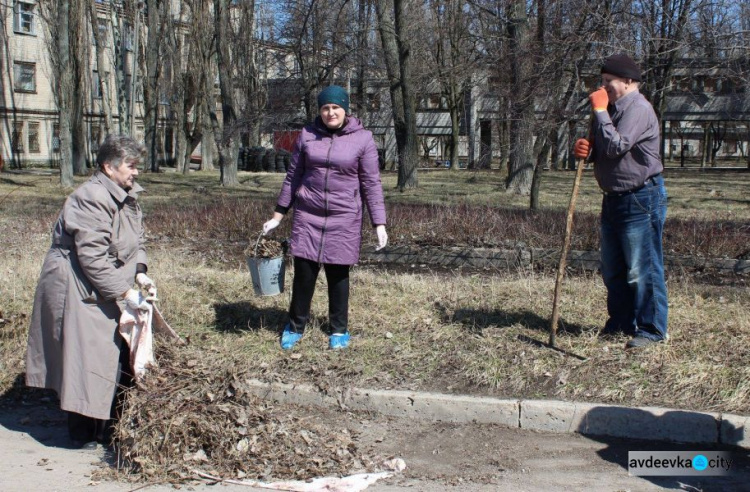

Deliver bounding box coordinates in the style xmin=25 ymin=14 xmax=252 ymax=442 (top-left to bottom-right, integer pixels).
xmin=0 ymin=170 xmax=750 ymax=414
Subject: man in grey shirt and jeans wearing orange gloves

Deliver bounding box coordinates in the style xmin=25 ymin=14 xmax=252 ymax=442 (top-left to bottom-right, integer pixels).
xmin=574 ymin=54 xmax=667 ymax=348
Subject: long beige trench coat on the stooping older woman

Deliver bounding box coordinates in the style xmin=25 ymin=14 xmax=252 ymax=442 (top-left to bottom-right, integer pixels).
xmin=26 ymin=172 xmax=147 ymax=420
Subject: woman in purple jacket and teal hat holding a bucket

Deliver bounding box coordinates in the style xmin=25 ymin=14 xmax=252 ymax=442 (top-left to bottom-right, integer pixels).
xmin=263 ymin=85 xmax=388 ymax=350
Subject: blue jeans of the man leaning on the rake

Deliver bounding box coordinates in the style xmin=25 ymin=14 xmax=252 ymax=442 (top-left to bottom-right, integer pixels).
xmin=601 ymin=175 xmax=667 ymax=340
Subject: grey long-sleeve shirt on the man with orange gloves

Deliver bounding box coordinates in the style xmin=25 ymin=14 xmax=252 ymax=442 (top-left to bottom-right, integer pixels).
xmin=593 ymin=91 xmax=664 ymax=192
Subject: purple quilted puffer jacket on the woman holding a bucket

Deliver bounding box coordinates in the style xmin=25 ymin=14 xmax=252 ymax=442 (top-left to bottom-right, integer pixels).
xmin=277 ymin=117 xmax=385 ymax=265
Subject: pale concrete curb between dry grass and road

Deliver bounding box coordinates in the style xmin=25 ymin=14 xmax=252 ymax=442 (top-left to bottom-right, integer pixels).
xmin=246 ymin=379 xmax=750 ymax=449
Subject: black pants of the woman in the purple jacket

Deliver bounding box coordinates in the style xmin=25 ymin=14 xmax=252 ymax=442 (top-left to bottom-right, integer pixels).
xmin=289 ymin=256 xmax=351 ymax=333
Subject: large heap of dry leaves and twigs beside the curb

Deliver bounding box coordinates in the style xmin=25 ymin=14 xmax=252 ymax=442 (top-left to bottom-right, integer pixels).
xmin=116 ymin=345 xmax=372 ymax=481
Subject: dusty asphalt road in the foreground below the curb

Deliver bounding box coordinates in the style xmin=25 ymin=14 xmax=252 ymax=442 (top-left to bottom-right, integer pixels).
xmin=0 ymin=400 xmax=750 ymax=492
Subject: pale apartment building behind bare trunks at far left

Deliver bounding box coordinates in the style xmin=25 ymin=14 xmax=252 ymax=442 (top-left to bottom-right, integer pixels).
xmin=0 ymin=0 xmax=152 ymax=167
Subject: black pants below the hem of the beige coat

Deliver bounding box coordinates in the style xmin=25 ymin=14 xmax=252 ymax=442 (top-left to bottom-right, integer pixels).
xmin=68 ymin=335 xmax=133 ymax=445
